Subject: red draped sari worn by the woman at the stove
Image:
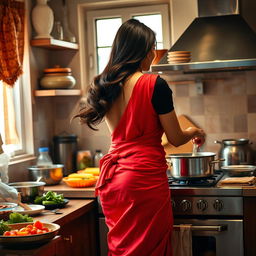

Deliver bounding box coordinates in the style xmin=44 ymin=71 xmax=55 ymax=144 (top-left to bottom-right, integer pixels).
xmin=96 ymin=74 xmax=173 ymax=256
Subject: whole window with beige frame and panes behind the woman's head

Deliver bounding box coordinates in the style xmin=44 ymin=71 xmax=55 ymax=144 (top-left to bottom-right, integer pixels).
xmin=87 ymin=5 xmax=170 ymax=80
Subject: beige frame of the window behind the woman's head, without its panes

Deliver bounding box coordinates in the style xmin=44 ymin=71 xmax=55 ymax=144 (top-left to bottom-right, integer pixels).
xmin=86 ymin=4 xmax=171 ymax=81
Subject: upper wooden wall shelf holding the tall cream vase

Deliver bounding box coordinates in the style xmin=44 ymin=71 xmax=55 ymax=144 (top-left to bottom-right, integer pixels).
xmin=30 ymin=38 xmax=78 ymax=50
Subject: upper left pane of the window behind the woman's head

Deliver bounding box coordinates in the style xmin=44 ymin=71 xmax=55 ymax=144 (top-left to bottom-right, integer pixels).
xmin=96 ymin=18 xmax=122 ymax=47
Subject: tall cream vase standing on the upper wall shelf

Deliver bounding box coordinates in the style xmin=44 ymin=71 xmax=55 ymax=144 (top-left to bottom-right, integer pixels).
xmin=32 ymin=0 xmax=54 ymax=38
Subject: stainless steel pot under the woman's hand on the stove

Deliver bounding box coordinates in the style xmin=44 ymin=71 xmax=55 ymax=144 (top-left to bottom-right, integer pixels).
xmin=166 ymin=152 xmax=224 ymax=180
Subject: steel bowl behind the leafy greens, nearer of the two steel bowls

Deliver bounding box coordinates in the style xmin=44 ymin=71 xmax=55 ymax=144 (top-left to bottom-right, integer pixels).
xmin=8 ymin=181 xmax=45 ymax=203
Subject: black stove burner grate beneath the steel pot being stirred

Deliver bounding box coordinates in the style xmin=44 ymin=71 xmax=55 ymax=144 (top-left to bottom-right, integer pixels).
xmin=168 ymin=171 xmax=223 ymax=187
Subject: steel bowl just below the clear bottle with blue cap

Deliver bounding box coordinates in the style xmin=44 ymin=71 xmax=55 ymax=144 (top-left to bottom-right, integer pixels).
xmin=28 ymin=164 xmax=64 ymax=186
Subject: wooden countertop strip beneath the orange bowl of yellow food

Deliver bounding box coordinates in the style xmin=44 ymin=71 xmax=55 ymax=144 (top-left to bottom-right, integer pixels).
xmin=44 ymin=182 xmax=96 ymax=199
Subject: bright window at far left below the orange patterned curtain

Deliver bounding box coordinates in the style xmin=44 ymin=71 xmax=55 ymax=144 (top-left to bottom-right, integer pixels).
xmin=0 ymin=9 xmax=34 ymax=162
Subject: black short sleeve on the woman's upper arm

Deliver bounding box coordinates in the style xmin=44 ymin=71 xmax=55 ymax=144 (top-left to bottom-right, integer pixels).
xmin=151 ymin=77 xmax=174 ymax=115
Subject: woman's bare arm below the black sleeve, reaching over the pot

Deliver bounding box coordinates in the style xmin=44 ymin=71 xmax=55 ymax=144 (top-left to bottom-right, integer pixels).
xmin=159 ymin=110 xmax=205 ymax=147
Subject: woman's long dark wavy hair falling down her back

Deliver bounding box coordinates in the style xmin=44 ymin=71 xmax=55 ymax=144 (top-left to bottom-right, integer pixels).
xmin=75 ymin=19 xmax=156 ymax=130
